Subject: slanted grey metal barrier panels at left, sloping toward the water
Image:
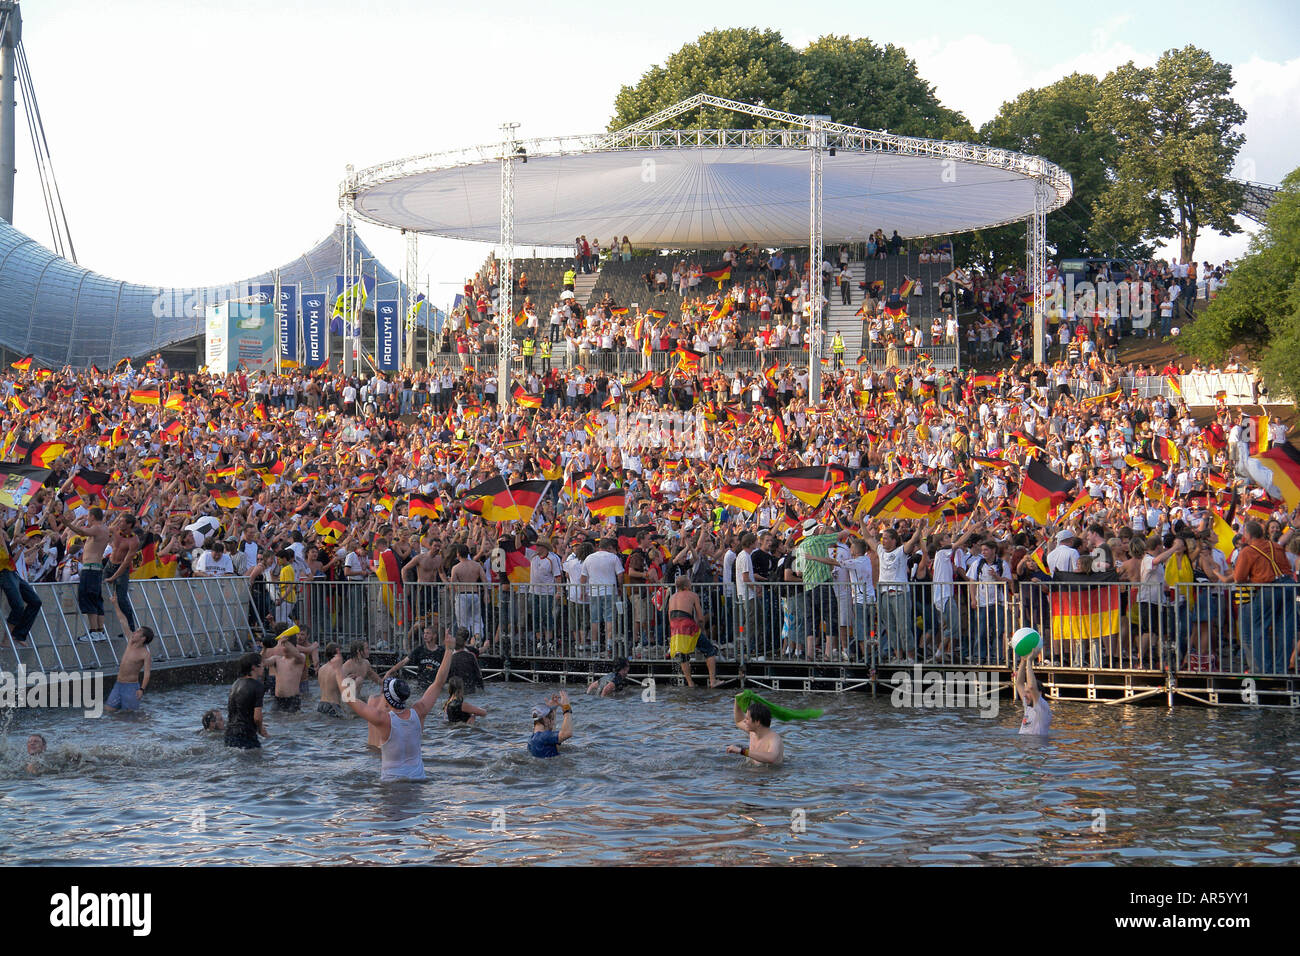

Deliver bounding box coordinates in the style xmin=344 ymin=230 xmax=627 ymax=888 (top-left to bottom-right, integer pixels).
xmin=0 ymin=578 xmax=263 ymax=671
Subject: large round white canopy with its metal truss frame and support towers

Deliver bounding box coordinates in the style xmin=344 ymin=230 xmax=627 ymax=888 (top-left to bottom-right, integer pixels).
xmin=339 ymin=94 xmax=1074 ymax=401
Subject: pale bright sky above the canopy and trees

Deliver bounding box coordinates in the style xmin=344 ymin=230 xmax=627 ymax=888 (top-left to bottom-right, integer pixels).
xmin=14 ymin=0 xmax=1300 ymax=306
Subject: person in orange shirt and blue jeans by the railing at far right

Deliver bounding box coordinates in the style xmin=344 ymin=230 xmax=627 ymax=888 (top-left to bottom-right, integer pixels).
xmin=1232 ymin=522 xmax=1295 ymax=674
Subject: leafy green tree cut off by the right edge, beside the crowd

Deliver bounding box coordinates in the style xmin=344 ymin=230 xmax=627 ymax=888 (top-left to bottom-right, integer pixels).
xmin=1182 ymin=169 xmax=1300 ymax=395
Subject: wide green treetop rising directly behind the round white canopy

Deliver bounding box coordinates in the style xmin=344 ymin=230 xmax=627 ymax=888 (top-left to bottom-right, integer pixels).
xmin=610 ymin=27 xmax=974 ymax=139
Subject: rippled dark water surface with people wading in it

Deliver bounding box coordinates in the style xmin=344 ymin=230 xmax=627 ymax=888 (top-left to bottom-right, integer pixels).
xmin=0 ymin=684 xmax=1300 ymax=865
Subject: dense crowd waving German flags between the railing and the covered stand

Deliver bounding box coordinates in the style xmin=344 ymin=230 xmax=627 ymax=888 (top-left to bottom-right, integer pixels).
xmin=0 ymin=343 xmax=1300 ymax=672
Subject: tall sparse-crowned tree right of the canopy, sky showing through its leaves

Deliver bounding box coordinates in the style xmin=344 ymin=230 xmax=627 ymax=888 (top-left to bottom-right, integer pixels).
xmin=1089 ymin=46 xmax=1245 ymax=263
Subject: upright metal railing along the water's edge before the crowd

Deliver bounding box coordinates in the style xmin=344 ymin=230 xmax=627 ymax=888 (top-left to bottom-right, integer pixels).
xmin=241 ymin=580 xmax=1300 ymax=676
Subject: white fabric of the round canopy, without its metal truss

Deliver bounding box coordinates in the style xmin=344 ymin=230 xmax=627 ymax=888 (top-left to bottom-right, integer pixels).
xmin=355 ymin=147 xmax=1055 ymax=248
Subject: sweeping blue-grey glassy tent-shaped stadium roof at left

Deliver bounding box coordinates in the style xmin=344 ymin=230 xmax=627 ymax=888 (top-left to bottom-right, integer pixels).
xmin=0 ymin=220 xmax=428 ymax=367
